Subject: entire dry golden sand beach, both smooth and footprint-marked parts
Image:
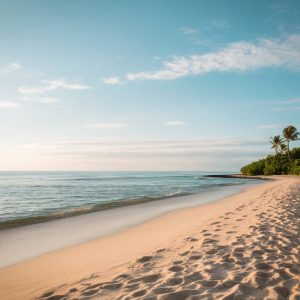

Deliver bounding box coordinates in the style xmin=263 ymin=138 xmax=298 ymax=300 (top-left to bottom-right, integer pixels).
xmin=0 ymin=176 xmax=300 ymax=300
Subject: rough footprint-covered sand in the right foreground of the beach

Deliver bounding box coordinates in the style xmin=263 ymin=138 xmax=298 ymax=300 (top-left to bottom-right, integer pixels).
xmin=38 ymin=179 xmax=300 ymax=300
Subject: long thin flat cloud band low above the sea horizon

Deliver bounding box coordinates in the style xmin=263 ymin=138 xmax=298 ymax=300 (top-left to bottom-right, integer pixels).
xmin=19 ymin=137 xmax=265 ymax=154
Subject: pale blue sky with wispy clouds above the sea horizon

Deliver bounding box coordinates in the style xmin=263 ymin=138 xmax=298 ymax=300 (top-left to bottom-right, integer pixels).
xmin=0 ymin=0 xmax=300 ymax=171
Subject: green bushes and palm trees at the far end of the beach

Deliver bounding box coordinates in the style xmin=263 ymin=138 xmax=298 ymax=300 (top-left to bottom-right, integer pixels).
xmin=241 ymin=125 xmax=300 ymax=176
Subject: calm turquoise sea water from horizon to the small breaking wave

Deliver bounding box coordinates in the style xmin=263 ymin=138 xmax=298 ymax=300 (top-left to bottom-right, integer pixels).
xmin=0 ymin=172 xmax=255 ymax=227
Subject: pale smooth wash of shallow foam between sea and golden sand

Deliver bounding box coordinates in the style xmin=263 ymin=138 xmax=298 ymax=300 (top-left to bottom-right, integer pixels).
xmin=0 ymin=183 xmax=255 ymax=267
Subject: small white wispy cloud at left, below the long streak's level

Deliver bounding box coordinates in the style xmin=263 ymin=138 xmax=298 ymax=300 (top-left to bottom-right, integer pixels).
xmin=19 ymin=79 xmax=91 ymax=95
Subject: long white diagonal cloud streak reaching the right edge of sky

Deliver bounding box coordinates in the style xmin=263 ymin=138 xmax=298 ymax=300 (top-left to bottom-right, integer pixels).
xmin=107 ymin=34 xmax=300 ymax=81
